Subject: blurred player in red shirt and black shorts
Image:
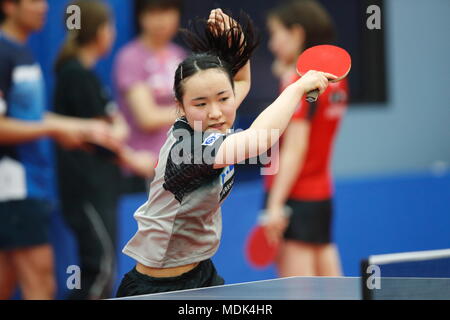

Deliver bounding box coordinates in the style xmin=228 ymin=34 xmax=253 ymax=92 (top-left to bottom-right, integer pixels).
xmin=265 ymin=0 xmax=348 ymax=277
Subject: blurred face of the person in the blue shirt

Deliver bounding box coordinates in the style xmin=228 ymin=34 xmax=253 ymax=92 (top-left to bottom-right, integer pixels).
xmin=9 ymin=0 xmax=48 ymax=32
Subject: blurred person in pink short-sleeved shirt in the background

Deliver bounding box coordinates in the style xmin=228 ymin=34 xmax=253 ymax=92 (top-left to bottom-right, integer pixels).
xmin=114 ymin=0 xmax=186 ymax=192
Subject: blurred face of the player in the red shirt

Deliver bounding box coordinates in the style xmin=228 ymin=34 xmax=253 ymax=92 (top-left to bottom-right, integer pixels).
xmin=267 ymin=17 xmax=304 ymax=64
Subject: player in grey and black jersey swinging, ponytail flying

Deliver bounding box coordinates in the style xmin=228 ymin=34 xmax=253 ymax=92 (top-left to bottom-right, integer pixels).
xmin=117 ymin=9 xmax=333 ymax=297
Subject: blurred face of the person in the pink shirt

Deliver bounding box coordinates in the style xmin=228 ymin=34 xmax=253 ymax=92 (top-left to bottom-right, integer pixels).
xmin=139 ymin=9 xmax=180 ymax=43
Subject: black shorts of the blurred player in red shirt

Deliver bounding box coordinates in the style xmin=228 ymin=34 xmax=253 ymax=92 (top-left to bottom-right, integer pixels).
xmin=266 ymin=196 xmax=333 ymax=244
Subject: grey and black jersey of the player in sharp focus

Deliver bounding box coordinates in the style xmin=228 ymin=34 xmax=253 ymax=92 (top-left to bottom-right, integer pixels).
xmin=123 ymin=118 xmax=234 ymax=268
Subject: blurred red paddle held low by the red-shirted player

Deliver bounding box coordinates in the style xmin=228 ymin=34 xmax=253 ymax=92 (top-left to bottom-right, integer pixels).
xmin=245 ymin=207 xmax=291 ymax=268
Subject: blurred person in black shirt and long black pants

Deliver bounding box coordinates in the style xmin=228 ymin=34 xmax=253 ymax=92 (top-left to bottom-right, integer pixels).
xmin=54 ymin=0 xmax=154 ymax=299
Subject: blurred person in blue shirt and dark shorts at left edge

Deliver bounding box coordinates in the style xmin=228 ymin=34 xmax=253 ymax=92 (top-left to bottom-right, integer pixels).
xmin=0 ymin=0 xmax=111 ymax=299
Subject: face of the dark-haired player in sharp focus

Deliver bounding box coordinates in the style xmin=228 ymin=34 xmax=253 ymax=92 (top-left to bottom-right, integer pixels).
xmin=181 ymin=69 xmax=237 ymax=133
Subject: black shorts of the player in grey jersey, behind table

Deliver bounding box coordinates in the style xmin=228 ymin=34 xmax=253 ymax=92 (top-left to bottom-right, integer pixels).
xmin=117 ymin=259 xmax=225 ymax=297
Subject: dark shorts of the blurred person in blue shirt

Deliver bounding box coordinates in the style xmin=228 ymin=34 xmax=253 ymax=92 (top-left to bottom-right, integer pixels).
xmin=0 ymin=199 xmax=51 ymax=251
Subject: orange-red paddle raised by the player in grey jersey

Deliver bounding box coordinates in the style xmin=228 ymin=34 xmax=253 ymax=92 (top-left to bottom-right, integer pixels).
xmin=297 ymin=44 xmax=352 ymax=102
